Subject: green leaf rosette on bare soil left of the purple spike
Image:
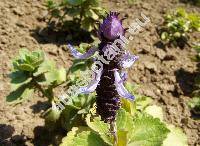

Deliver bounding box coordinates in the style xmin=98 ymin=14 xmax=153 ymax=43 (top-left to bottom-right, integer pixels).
xmin=7 ymin=49 xmax=66 ymax=103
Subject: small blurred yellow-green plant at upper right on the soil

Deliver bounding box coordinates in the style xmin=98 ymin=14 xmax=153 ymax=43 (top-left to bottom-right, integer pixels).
xmin=158 ymin=8 xmax=200 ymax=48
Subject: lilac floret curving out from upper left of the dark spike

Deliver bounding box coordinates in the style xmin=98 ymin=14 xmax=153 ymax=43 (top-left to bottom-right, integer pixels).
xmin=67 ymin=44 xmax=98 ymax=59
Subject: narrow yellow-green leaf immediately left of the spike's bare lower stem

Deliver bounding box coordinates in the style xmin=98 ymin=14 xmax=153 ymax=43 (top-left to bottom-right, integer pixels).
xmin=86 ymin=114 xmax=113 ymax=146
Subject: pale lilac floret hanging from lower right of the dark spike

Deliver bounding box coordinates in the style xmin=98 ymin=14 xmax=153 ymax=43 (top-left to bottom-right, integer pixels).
xmin=114 ymin=70 xmax=135 ymax=100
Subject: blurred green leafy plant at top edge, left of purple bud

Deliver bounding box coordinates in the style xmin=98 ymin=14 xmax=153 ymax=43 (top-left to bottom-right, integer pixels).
xmin=46 ymin=0 xmax=106 ymax=32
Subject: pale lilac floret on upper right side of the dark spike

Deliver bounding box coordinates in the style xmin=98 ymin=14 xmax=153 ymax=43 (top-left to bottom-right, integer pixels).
xmin=120 ymin=52 xmax=139 ymax=68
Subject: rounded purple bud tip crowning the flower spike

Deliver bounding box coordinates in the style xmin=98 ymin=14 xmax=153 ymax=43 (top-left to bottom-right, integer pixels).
xmin=99 ymin=12 xmax=124 ymax=41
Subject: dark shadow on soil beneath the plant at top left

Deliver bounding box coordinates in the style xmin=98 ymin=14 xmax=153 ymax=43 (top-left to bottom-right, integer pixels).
xmin=31 ymin=21 xmax=95 ymax=45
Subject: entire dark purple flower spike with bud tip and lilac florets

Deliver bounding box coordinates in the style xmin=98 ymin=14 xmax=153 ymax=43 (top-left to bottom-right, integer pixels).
xmin=68 ymin=12 xmax=138 ymax=133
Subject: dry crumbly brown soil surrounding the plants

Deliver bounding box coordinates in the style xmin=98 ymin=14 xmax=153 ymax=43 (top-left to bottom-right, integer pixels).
xmin=0 ymin=0 xmax=200 ymax=146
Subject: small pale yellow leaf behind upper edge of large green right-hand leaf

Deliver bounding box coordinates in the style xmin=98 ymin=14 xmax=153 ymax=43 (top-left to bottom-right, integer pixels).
xmin=144 ymin=105 xmax=164 ymax=121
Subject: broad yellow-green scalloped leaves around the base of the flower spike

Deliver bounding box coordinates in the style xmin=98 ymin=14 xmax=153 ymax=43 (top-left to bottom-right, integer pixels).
xmin=60 ymin=83 xmax=188 ymax=146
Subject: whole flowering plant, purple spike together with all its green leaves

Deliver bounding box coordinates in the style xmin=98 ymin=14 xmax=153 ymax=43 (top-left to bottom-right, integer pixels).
xmin=7 ymin=12 xmax=187 ymax=146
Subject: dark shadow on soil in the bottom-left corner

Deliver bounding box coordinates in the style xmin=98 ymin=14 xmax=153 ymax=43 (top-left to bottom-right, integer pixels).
xmin=0 ymin=124 xmax=26 ymax=146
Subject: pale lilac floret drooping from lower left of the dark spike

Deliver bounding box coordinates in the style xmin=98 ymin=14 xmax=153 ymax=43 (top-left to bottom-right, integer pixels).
xmin=79 ymin=70 xmax=102 ymax=94
